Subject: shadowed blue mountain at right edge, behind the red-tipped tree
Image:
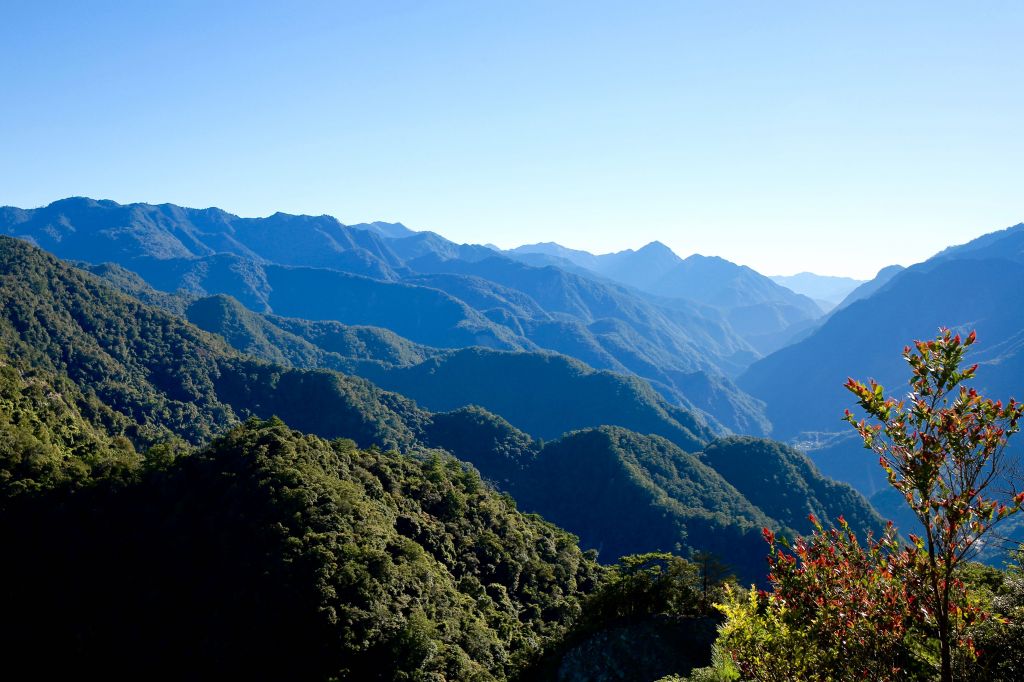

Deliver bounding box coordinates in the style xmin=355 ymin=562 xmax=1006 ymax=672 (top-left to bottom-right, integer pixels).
xmin=739 ymin=226 xmax=1024 ymax=493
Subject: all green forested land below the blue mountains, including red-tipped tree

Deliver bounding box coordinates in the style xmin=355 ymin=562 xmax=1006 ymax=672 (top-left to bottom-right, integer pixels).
xmin=0 ymin=232 xmax=1024 ymax=681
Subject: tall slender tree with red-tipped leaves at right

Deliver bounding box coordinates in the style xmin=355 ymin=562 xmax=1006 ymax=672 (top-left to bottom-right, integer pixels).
xmin=845 ymin=329 xmax=1024 ymax=682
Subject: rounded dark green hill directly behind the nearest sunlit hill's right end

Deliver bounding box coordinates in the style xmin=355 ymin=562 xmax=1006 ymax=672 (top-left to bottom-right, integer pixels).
xmin=515 ymin=427 xmax=775 ymax=576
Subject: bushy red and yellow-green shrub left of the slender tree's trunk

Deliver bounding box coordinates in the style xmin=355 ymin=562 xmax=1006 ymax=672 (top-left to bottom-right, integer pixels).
xmin=717 ymin=515 xmax=923 ymax=682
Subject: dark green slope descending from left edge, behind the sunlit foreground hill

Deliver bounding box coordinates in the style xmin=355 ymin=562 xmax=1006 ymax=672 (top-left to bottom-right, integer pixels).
xmin=0 ymin=237 xmax=422 ymax=445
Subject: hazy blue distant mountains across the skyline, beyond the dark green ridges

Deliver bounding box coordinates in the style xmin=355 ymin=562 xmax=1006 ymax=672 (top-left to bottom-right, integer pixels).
xmin=6 ymin=193 xmax=1020 ymax=501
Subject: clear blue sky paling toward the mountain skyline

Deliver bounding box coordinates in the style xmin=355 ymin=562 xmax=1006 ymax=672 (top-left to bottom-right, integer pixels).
xmin=0 ymin=0 xmax=1024 ymax=278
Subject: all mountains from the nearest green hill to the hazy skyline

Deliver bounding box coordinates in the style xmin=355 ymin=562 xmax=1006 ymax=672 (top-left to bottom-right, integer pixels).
xmin=0 ymin=199 xmax=1024 ymax=680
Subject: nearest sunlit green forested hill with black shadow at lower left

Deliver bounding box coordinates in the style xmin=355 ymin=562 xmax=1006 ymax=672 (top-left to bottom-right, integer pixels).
xmin=0 ymin=368 xmax=603 ymax=680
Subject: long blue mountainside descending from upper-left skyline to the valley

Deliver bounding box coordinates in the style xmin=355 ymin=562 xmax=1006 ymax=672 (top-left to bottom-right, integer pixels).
xmin=0 ymin=199 xmax=770 ymax=433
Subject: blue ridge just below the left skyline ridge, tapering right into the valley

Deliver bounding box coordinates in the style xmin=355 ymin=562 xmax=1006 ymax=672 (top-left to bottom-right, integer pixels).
xmin=128 ymin=249 xmax=764 ymax=433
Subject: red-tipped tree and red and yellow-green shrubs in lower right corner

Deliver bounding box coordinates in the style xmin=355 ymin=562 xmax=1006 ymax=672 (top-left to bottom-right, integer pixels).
xmin=688 ymin=330 xmax=1024 ymax=682
